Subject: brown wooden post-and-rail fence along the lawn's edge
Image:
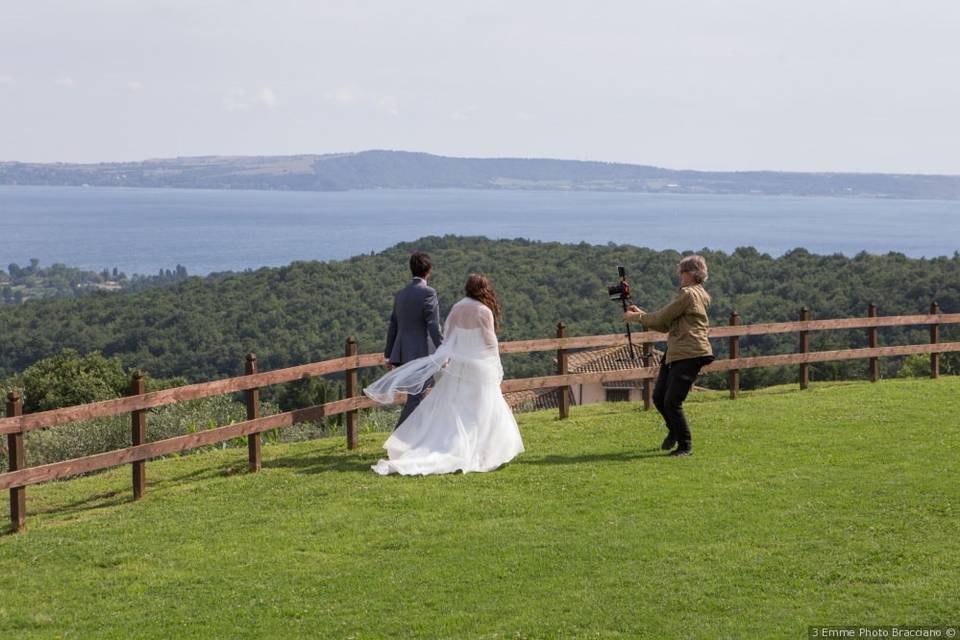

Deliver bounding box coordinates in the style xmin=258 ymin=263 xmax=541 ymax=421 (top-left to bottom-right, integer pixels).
xmin=0 ymin=303 xmax=960 ymax=531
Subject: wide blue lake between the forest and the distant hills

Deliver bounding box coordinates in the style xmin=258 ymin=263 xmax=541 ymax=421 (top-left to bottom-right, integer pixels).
xmin=0 ymin=186 xmax=960 ymax=274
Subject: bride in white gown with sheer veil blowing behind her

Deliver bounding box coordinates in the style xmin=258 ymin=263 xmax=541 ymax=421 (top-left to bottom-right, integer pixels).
xmin=363 ymin=274 xmax=523 ymax=475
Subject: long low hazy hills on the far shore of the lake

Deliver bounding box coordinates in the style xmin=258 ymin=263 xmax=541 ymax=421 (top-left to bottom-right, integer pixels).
xmin=0 ymin=151 xmax=960 ymax=200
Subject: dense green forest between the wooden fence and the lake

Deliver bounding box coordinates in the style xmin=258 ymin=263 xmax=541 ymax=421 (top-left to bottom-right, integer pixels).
xmin=0 ymin=236 xmax=960 ymax=387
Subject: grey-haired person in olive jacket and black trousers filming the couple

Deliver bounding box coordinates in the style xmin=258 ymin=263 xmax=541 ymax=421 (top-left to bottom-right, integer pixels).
xmin=623 ymin=255 xmax=714 ymax=456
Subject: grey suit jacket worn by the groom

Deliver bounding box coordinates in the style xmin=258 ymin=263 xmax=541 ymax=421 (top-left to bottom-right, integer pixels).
xmin=383 ymin=278 xmax=443 ymax=364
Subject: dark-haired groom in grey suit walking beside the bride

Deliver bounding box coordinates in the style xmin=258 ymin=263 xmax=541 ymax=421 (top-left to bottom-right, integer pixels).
xmin=383 ymin=251 xmax=443 ymax=429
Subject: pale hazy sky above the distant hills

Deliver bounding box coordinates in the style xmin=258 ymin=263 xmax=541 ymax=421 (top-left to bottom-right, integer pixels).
xmin=0 ymin=0 xmax=960 ymax=174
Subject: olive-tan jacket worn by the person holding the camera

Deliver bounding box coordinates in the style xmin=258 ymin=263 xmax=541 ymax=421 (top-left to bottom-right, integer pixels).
xmin=640 ymin=284 xmax=713 ymax=364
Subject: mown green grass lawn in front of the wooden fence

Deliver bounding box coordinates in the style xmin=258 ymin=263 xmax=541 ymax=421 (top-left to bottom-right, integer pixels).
xmin=0 ymin=378 xmax=960 ymax=638
